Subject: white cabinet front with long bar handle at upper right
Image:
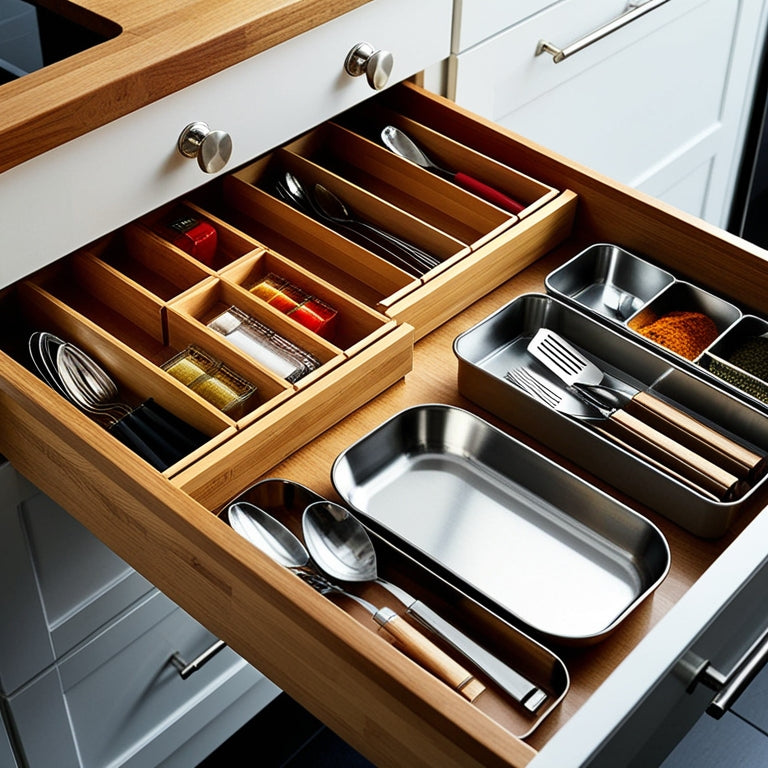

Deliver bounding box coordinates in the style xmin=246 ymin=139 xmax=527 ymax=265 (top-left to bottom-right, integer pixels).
xmin=448 ymin=0 xmax=764 ymax=226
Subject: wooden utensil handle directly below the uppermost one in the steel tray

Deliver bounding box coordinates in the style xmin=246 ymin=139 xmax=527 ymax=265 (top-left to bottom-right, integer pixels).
xmin=608 ymin=409 xmax=748 ymax=501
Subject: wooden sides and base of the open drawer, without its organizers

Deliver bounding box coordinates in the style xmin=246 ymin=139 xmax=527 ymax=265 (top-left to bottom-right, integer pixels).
xmin=0 ymin=85 xmax=768 ymax=767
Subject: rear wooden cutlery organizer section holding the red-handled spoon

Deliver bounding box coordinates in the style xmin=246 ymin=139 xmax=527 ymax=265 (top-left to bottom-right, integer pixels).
xmin=194 ymin=84 xmax=576 ymax=339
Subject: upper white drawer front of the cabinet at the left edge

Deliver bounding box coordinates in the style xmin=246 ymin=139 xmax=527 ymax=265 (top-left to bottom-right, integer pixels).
xmin=0 ymin=462 xmax=153 ymax=694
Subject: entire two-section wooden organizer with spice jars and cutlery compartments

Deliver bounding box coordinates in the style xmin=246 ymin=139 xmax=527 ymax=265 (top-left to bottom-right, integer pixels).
xmin=0 ymin=85 xmax=575 ymax=493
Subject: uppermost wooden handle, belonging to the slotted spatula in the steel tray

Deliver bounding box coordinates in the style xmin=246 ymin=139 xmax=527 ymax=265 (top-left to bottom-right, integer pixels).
xmin=627 ymin=392 xmax=768 ymax=482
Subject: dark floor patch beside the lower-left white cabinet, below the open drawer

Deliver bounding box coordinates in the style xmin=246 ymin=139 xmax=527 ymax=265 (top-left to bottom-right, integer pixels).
xmin=198 ymin=694 xmax=374 ymax=768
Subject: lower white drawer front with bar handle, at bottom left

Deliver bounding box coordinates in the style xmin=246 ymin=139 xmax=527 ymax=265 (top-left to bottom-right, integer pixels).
xmin=8 ymin=593 xmax=278 ymax=768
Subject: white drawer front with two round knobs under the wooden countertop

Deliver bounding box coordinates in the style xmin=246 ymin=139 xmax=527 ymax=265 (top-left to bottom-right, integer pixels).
xmin=0 ymin=0 xmax=452 ymax=292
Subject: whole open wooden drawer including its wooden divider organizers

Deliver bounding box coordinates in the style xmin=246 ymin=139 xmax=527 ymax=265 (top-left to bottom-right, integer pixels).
xmin=0 ymin=85 xmax=768 ymax=768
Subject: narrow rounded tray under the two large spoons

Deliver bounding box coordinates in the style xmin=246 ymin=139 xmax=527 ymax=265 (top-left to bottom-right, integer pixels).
xmin=218 ymin=477 xmax=569 ymax=738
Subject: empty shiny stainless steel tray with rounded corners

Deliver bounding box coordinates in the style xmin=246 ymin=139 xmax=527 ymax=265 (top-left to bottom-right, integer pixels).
xmin=331 ymin=404 xmax=669 ymax=643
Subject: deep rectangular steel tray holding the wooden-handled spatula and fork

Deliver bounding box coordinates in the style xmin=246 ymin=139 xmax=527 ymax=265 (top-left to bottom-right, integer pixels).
xmin=454 ymin=294 xmax=768 ymax=538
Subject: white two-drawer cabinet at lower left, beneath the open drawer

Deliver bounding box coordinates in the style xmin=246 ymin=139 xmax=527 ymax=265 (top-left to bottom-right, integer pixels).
xmin=0 ymin=463 xmax=279 ymax=768
